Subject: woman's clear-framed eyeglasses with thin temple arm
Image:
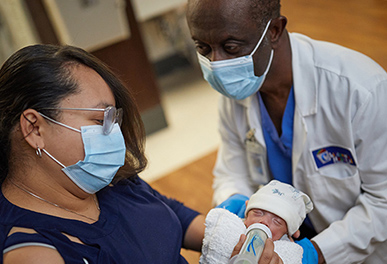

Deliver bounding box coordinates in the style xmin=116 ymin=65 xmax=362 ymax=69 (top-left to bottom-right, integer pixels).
xmin=42 ymin=106 xmax=122 ymax=135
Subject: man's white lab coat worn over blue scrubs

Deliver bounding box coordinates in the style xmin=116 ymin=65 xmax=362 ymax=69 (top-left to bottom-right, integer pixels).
xmin=214 ymin=33 xmax=387 ymax=264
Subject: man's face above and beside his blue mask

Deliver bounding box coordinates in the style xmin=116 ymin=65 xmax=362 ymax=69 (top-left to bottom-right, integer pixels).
xmin=187 ymin=0 xmax=271 ymax=76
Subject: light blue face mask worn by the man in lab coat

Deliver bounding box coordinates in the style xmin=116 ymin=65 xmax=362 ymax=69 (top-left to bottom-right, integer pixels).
xmin=198 ymin=20 xmax=274 ymax=100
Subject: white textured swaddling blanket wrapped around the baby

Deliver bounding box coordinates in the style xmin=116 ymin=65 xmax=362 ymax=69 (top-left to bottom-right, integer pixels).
xmin=199 ymin=208 xmax=303 ymax=264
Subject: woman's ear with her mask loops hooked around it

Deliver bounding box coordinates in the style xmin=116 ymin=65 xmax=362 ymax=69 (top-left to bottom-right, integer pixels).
xmin=20 ymin=109 xmax=47 ymax=149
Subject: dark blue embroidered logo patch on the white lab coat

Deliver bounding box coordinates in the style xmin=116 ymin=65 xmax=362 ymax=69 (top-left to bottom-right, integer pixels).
xmin=312 ymin=146 xmax=356 ymax=168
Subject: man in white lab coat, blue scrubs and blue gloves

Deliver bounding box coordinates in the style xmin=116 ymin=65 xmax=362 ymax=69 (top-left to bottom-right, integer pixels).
xmin=187 ymin=0 xmax=387 ymax=264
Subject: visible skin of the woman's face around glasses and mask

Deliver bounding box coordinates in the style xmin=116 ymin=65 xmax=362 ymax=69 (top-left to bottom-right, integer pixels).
xmin=45 ymin=65 xmax=115 ymax=169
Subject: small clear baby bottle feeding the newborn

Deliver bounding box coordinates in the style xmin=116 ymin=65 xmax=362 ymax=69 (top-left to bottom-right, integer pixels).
xmin=230 ymin=223 xmax=271 ymax=264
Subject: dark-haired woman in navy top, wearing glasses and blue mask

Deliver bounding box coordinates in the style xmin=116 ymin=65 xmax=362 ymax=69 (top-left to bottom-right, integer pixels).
xmin=0 ymin=45 xmax=277 ymax=264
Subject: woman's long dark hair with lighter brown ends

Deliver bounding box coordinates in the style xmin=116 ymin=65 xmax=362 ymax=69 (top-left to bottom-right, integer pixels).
xmin=0 ymin=45 xmax=147 ymax=183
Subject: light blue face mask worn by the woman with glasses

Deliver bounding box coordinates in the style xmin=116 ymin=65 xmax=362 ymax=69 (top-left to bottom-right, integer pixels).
xmin=41 ymin=114 xmax=126 ymax=194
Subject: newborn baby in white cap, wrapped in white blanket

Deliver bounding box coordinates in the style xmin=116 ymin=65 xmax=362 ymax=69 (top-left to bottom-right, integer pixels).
xmin=200 ymin=180 xmax=313 ymax=264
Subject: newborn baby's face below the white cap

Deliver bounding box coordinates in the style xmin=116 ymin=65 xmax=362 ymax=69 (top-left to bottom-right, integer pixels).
xmin=245 ymin=209 xmax=288 ymax=241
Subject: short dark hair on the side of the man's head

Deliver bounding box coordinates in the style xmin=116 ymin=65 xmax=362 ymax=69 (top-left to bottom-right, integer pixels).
xmin=249 ymin=0 xmax=281 ymax=26
